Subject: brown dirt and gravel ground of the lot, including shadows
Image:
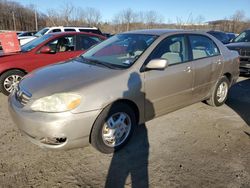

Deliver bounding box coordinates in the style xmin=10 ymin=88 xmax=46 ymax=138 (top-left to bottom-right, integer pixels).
xmin=0 ymin=78 xmax=250 ymax=188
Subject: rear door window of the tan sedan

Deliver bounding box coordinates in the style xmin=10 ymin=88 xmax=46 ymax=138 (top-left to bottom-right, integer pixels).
xmin=189 ymin=35 xmax=220 ymax=60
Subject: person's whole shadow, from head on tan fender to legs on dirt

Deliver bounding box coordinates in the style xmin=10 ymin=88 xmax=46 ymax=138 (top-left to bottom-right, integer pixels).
xmin=105 ymin=72 xmax=155 ymax=188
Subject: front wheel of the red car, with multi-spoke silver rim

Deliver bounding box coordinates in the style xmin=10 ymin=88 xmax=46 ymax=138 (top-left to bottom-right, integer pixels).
xmin=0 ymin=70 xmax=25 ymax=96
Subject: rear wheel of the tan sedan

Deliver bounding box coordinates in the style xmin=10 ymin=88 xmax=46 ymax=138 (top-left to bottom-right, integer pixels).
xmin=206 ymin=76 xmax=229 ymax=107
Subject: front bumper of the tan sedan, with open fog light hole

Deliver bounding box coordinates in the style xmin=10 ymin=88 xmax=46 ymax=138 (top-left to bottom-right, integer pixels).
xmin=9 ymin=95 xmax=101 ymax=149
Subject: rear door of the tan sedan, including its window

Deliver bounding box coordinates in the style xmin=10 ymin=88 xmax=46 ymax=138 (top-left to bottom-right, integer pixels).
xmin=189 ymin=34 xmax=223 ymax=101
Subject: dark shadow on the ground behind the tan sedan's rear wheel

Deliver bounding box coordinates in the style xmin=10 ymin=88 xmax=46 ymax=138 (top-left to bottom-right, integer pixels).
xmin=226 ymin=79 xmax=250 ymax=126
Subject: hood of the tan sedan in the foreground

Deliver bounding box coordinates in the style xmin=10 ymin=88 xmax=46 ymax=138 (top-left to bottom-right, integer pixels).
xmin=20 ymin=60 xmax=120 ymax=99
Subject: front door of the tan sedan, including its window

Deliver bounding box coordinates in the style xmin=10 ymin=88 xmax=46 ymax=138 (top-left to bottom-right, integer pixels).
xmin=145 ymin=35 xmax=194 ymax=120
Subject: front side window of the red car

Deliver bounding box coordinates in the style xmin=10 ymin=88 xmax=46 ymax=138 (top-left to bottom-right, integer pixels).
xmin=45 ymin=36 xmax=75 ymax=52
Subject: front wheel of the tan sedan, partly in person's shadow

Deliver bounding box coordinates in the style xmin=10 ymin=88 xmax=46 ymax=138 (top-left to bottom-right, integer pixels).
xmin=90 ymin=103 xmax=136 ymax=154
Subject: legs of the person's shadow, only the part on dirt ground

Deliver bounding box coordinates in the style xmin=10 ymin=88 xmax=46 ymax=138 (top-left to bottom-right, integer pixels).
xmin=105 ymin=124 xmax=149 ymax=188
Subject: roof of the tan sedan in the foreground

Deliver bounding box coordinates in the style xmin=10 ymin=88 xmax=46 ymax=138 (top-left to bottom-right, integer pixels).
xmin=124 ymin=29 xmax=210 ymax=36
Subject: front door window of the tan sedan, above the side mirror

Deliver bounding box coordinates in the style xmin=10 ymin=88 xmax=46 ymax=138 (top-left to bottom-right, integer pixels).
xmin=147 ymin=36 xmax=189 ymax=65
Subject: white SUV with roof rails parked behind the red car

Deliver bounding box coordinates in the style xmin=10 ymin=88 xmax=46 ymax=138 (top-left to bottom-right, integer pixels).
xmin=19 ymin=26 xmax=102 ymax=46
